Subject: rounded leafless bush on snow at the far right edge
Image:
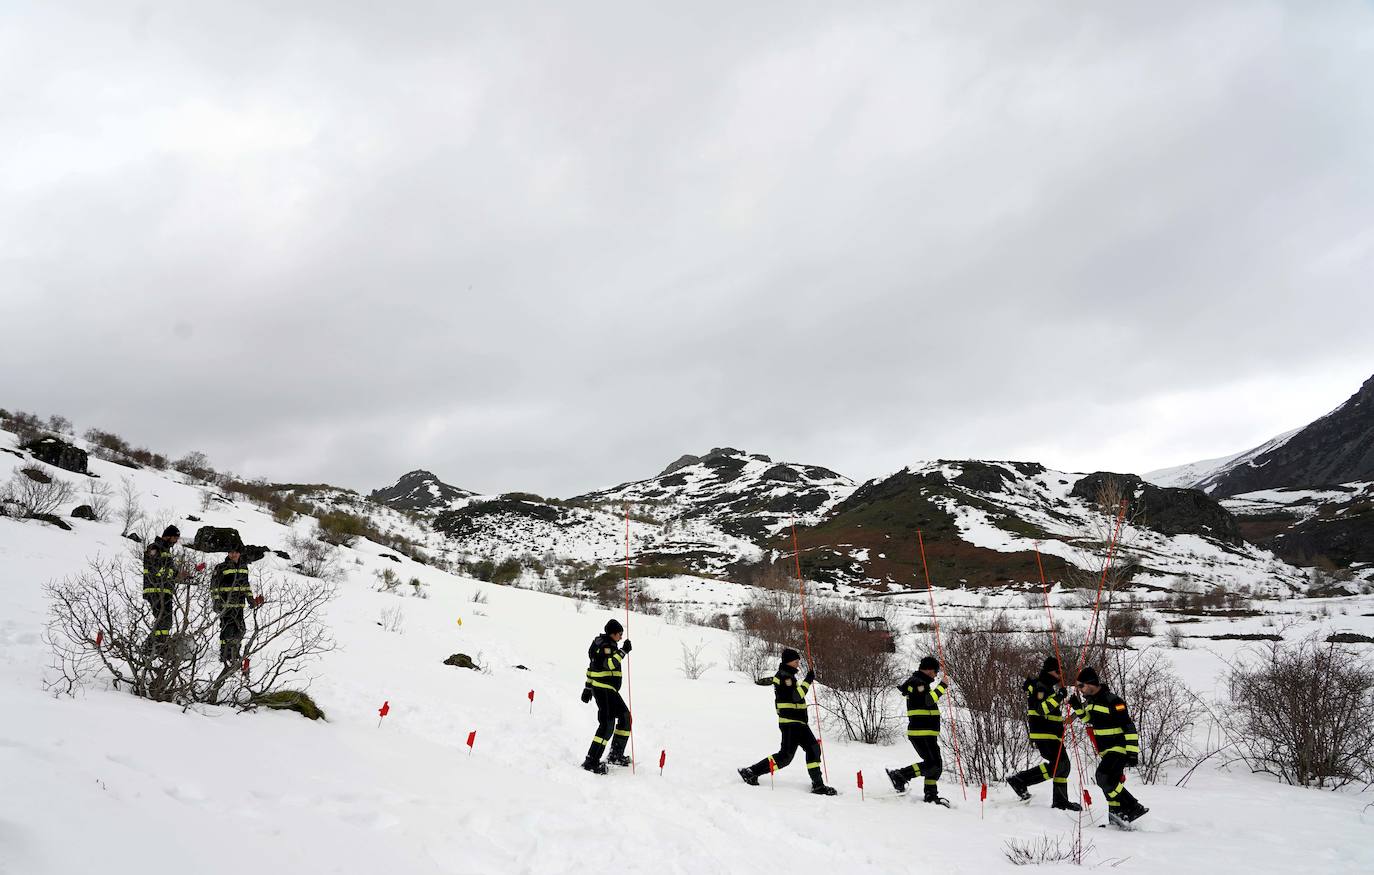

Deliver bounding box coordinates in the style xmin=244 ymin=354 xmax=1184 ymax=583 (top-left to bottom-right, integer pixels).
xmin=1223 ymin=636 xmax=1374 ymax=788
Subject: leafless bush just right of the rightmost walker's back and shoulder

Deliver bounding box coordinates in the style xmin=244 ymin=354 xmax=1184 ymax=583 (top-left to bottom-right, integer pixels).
xmin=1109 ymin=648 xmax=1205 ymax=784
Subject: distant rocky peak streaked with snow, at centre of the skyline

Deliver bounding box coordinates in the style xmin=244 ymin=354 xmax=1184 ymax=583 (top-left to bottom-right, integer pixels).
xmin=577 ymin=446 xmax=855 ymax=541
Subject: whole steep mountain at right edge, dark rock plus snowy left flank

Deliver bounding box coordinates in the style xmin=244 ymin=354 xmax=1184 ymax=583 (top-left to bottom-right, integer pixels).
xmin=1145 ymin=376 xmax=1374 ymax=497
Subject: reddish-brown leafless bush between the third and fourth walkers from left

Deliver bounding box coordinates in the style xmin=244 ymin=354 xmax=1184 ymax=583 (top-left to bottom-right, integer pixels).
xmin=926 ymin=614 xmax=1033 ymax=783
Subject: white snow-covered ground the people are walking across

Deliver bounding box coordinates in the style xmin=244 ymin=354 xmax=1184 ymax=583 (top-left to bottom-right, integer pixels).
xmin=0 ymin=433 xmax=1374 ymax=875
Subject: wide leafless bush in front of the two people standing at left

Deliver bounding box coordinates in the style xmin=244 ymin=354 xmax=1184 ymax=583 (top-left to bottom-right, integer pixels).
xmin=44 ymin=559 xmax=334 ymax=709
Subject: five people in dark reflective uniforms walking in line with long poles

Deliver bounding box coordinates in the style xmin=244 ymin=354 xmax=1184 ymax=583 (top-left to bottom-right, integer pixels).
xmin=583 ymin=620 xmax=1150 ymax=827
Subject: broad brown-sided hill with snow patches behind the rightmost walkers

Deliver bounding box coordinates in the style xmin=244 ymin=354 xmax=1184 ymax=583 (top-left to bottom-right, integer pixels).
xmin=791 ymin=462 xmax=1307 ymax=592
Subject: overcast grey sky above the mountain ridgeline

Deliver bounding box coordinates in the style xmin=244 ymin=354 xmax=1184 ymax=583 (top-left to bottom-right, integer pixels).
xmin=0 ymin=0 xmax=1374 ymax=496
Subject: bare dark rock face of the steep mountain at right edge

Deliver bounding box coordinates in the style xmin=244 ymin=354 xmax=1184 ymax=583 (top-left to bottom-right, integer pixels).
xmin=1202 ymin=376 xmax=1374 ymax=497
